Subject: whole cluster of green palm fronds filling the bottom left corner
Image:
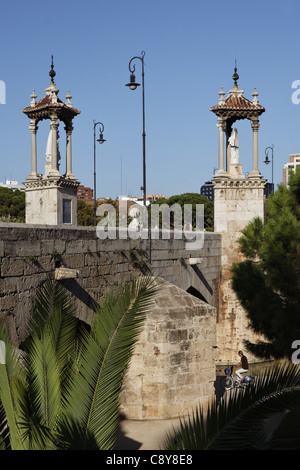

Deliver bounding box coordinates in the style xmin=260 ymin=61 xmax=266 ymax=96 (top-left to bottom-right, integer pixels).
xmin=0 ymin=277 xmax=156 ymax=450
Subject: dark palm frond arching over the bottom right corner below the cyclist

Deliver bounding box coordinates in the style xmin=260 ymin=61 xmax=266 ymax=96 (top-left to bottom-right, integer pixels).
xmin=164 ymin=363 xmax=300 ymax=451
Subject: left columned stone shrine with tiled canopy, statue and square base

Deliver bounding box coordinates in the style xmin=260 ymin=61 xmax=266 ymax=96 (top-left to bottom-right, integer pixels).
xmin=23 ymin=55 xmax=80 ymax=225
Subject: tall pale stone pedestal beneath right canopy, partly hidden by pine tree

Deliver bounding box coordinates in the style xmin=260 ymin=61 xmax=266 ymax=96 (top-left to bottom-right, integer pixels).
xmin=214 ymin=176 xmax=266 ymax=364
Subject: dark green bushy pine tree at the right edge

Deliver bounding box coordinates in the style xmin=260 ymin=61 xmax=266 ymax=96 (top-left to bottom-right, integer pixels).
xmin=232 ymin=171 xmax=300 ymax=359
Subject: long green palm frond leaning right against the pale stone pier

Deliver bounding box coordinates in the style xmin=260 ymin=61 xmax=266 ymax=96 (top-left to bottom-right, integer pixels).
xmin=61 ymin=277 xmax=157 ymax=449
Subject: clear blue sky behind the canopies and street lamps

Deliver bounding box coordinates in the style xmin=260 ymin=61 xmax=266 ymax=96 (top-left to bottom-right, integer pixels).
xmin=0 ymin=0 xmax=300 ymax=198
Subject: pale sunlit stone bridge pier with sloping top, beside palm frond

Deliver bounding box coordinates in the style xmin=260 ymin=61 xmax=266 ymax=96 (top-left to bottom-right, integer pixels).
xmin=121 ymin=281 xmax=216 ymax=419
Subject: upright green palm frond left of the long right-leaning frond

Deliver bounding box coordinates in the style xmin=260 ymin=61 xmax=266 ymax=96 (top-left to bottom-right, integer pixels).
xmin=22 ymin=280 xmax=86 ymax=429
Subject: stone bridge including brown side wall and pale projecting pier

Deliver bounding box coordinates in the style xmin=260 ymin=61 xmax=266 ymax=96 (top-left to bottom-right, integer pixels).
xmin=0 ymin=223 xmax=221 ymax=419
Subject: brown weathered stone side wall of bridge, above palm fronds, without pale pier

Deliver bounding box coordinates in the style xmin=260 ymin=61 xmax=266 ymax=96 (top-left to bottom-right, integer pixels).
xmin=0 ymin=223 xmax=221 ymax=345
